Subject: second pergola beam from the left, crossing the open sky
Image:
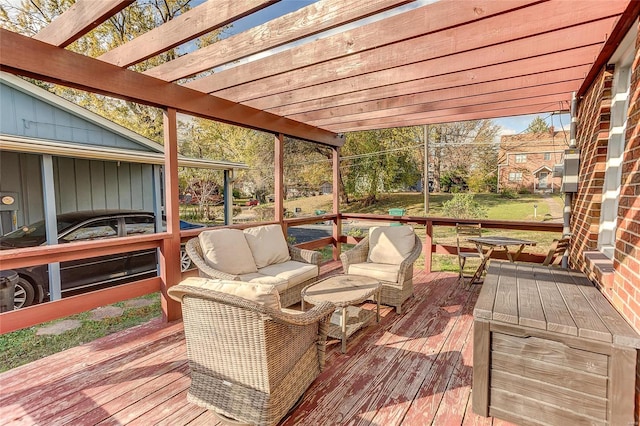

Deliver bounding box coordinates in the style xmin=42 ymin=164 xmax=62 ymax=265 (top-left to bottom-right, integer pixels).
xmin=98 ymin=0 xmax=280 ymax=67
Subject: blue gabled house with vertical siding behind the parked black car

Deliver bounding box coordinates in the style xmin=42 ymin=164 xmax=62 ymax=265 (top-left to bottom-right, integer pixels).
xmin=0 ymin=73 xmax=246 ymax=234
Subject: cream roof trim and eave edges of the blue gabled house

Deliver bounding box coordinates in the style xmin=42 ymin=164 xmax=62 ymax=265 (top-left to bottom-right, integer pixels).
xmin=0 ymin=72 xmax=248 ymax=170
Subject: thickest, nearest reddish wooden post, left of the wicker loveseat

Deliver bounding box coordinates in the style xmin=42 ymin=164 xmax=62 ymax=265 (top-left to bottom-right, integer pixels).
xmin=159 ymin=108 xmax=182 ymax=321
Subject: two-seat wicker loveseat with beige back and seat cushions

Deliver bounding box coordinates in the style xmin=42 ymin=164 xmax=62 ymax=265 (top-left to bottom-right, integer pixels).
xmin=186 ymin=225 xmax=320 ymax=307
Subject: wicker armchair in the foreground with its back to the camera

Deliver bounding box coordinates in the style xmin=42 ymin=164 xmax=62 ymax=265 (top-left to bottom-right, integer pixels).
xmin=169 ymin=277 xmax=335 ymax=425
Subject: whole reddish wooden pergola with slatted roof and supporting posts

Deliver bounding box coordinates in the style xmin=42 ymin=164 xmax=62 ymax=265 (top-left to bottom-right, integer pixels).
xmin=0 ymin=0 xmax=640 ymax=328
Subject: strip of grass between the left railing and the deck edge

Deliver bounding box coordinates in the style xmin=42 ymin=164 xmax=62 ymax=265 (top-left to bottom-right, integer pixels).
xmin=0 ymin=293 xmax=161 ymax=372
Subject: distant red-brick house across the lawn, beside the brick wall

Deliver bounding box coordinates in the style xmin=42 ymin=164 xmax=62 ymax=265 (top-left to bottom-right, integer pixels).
xmin=498 ymin=127 xmax=569 ymax=193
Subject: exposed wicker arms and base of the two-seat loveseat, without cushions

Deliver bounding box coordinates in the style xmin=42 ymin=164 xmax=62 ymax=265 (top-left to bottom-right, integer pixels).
xmin=185 ymin=237 xmax=321 ymax=307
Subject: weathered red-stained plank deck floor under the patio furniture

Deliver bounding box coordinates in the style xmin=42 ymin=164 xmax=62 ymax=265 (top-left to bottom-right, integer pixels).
xmin=0 ymin=262 xmax=508 ymax=426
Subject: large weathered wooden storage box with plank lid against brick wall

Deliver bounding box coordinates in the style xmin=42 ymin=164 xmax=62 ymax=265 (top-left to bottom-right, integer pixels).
xmin=473 ymin=261 xmax=640 ymax=425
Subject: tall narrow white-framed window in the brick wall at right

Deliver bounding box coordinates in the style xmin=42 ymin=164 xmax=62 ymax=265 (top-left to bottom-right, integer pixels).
xmin=598 ymin=31 xmax=635 ymax=259
